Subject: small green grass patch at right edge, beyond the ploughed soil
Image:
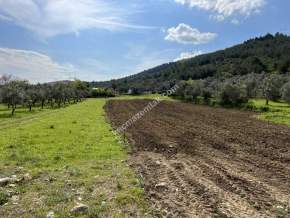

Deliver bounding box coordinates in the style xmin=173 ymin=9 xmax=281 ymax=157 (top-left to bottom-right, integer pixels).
xmin=251 ymin=99 xmax=290 ymax=125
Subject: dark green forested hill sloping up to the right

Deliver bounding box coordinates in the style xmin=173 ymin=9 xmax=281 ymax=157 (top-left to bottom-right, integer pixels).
xmin=93 ymin=33 xmax=290 ymax=92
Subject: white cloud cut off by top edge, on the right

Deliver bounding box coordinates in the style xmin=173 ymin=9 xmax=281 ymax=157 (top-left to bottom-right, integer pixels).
xmin=175 ymin=0 xmax=266 ymax=21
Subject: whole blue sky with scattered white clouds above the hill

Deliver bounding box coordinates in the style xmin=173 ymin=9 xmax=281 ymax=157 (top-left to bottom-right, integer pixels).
xmin=0 ymin=0 xmax=290 ymax=82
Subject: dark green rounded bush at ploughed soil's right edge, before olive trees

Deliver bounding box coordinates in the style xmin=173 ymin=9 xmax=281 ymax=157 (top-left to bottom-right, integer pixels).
xmin=219 ymin=84 xmax=249 ymax=106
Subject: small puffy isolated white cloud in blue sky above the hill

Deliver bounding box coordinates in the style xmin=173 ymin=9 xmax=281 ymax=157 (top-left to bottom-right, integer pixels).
xmin=165 ymin=23 xmax=217 ymax=45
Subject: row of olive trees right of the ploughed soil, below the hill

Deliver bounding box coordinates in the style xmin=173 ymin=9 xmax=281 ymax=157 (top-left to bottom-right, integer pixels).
xmin=174 ymin=73 xmax=290 ymax=107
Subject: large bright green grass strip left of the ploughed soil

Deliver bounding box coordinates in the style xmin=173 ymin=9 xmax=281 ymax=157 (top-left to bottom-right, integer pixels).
xmin=0 ymin=99 xmax=147 ymax=217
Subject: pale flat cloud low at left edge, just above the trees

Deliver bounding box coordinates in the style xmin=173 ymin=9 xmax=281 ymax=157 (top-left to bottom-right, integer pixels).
xmin=0 ymin=48 xmax=76 ymax=83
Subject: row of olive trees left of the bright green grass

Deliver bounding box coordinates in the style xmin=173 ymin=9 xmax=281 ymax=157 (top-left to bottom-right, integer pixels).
xmin=0 ymin=75 xmax=90 ymax=115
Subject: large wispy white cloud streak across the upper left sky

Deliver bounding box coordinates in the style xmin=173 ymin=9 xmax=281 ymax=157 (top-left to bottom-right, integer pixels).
xmin=0 ymin=0 xmax=148 ymax=38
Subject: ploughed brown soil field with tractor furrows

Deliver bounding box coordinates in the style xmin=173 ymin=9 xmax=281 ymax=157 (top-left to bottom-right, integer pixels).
xmin=105 ymin=100 xmax=290 ymax=217
